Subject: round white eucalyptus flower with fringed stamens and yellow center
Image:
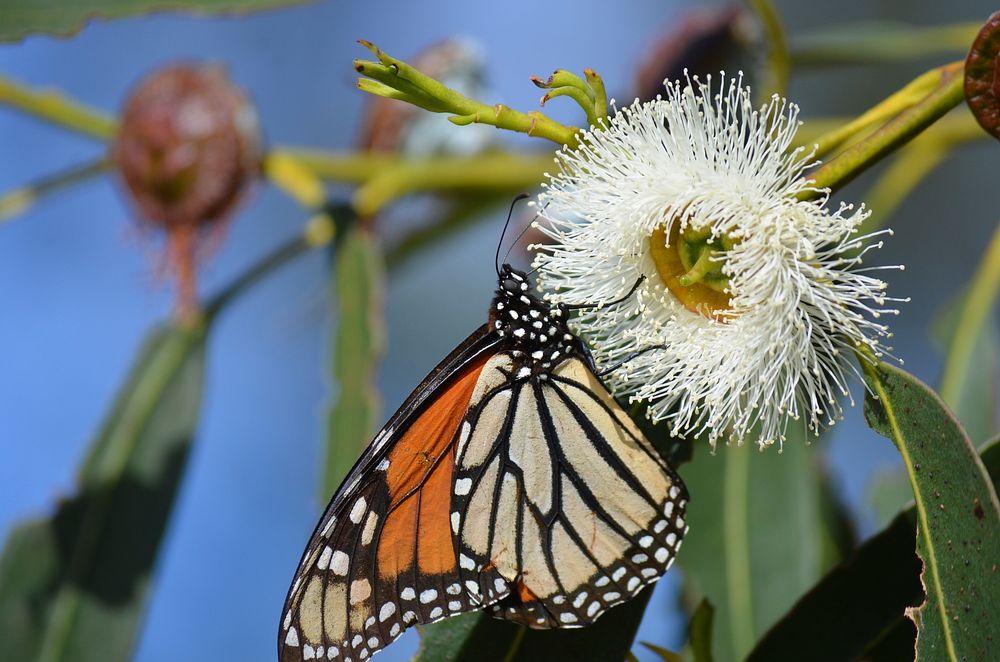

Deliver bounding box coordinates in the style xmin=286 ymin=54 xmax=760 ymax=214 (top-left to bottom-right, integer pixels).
xmin=534 ymin=76 xmax=897 ymax=447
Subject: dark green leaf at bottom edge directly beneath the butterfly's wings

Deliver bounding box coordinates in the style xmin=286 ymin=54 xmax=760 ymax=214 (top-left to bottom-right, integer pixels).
xmin=414 ymin=587 xmax=653 ymax=662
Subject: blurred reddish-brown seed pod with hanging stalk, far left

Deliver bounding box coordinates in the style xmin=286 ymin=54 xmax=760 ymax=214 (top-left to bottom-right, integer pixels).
xmin=112 ymin=63 xmax=261 ymax=316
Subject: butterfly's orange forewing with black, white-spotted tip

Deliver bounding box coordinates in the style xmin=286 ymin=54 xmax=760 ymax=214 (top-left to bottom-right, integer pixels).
xmin=279 ymin=331 xmax=508 ymax=660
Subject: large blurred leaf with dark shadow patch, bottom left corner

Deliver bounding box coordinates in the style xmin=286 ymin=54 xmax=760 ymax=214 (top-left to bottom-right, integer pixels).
xmin=0 ymin=324 xmax=206 ymax=662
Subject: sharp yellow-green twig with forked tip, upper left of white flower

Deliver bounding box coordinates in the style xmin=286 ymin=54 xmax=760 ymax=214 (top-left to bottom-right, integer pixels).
xmin=354 ymin=40 xmax=579 ymax=146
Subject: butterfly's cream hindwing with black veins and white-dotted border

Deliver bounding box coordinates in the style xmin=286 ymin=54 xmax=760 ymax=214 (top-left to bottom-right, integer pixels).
xmin=452 ymin=354 xmax=687 ymax=628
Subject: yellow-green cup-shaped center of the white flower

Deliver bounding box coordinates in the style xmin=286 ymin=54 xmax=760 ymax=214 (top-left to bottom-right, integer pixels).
xmin=649 ymin=222 xmax=732 ymax=322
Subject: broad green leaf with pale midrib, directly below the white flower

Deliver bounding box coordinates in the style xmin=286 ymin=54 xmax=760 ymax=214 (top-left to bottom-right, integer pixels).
xmin=678 ymin=435 xmax=840 ymax=661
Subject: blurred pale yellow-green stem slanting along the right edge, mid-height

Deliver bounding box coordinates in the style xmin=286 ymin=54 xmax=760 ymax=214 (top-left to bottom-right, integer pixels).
xmin=939 ymin=227 xmax=1000 ymax=406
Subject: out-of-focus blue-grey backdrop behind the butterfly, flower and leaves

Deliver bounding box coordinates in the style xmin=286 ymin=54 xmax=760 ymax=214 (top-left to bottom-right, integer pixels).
xmin=0 ymin=0 xmax=998 ymax=662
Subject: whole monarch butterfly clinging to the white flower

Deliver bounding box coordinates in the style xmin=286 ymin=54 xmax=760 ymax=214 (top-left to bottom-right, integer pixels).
xmin=278 ymin=226 xmax=688 ymax=662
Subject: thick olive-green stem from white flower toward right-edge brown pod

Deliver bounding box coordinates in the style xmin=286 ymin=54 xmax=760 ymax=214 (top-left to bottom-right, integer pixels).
xmin=801 ymin=62 xmax=965 ymax=199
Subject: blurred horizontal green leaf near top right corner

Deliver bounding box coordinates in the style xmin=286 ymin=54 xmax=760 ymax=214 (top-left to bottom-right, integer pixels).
xmin=791 ymin=21 xmax=982 ymax=67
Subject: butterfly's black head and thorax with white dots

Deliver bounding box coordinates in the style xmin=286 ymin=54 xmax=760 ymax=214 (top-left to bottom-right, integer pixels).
xmin=490 ymin=264 xmax=579 ymax=370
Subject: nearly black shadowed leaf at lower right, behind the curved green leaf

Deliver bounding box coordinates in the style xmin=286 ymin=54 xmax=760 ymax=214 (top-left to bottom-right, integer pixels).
xmin=747 ymin=440 xmax=1000 ymax=662
